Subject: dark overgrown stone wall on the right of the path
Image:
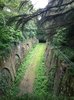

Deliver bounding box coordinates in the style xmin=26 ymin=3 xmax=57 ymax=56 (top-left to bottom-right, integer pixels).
xmin=46 ymin=43 xmax=74 ymax=96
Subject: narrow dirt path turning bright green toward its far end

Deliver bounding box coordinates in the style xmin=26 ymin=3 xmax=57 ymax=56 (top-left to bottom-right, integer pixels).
xmin=19 ymin=44 xmax=45 ymax=95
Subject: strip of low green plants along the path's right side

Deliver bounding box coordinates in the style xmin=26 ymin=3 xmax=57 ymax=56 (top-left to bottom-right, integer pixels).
xmin=34 ymin=56 xmax=48 ymax=98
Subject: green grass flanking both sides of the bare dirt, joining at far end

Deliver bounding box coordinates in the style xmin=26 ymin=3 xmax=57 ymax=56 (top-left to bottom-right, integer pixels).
xmin=0 ymin=44 xmax=47 ymax=100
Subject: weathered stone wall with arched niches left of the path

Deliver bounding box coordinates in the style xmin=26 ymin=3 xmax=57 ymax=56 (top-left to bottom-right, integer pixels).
xmin=0 ymin=38 xmax=38 ymax=95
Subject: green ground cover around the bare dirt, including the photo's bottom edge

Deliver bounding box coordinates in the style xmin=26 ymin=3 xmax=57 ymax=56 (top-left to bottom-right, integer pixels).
xmin=0 ymin=44 xmax=74 ymax=100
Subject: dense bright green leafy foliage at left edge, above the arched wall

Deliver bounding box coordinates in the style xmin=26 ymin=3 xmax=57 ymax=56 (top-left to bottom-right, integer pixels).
xmin=0 ymin=26 xmax=23 ymax=57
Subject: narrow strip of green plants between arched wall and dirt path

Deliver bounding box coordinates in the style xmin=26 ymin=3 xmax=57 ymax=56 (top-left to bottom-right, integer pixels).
xmin=0 ymin=45 xmax=36 ymax=100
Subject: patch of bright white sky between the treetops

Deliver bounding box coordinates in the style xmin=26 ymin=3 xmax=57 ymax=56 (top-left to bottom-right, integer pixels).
xmin=31 ymin=0 xmax=48 ymax=9
